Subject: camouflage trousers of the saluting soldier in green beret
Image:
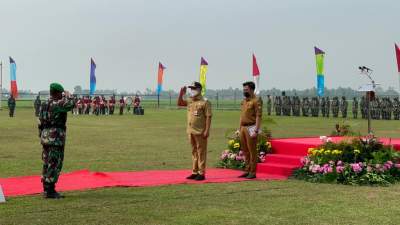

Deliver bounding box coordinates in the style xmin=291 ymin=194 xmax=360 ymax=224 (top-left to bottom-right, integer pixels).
xmin=42 ymin=145 xmax=64 ymax=184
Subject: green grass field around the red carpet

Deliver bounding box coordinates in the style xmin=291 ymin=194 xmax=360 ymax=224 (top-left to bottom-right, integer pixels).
xmin=0 ymin=108 xmax=400 ymax=225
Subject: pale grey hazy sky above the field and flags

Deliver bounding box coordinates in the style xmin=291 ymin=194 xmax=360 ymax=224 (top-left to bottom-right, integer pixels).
xmin=0 ymin=0 xmax=400 ymax=91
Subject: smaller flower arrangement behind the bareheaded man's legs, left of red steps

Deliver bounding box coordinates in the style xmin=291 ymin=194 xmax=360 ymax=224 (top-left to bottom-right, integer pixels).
xmin=217 ymin=132 xmax=272 ymax=169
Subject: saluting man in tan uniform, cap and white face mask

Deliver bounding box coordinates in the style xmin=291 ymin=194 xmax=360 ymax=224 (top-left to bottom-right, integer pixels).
xmin=178 ymin=82 xmax=212 ymax=181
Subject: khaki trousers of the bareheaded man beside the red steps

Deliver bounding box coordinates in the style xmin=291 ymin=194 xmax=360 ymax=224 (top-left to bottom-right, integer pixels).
xmin=240 ymin=126 xmax=258 ymax=174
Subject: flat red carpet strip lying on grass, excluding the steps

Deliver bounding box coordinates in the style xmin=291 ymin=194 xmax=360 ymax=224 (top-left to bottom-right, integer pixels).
xmin=0 ymin=169 xmax=286 ymax=197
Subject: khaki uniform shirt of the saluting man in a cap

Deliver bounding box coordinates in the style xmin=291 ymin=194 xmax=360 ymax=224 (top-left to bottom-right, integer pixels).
xmin=187 ymin=97 xmax=212 ymax=135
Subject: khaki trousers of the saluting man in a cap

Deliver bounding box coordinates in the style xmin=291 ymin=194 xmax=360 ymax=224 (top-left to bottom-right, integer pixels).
xmin=189 ymin=134 xmax=207 ymax=175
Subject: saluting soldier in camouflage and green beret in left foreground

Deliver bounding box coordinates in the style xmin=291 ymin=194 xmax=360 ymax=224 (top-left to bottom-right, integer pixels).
xmin=38 ymin=83 xmax=75 ymax=198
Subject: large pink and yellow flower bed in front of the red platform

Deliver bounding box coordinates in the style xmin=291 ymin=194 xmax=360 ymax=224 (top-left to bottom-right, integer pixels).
xmin=294 ymin=136 xmax=400 ymax=185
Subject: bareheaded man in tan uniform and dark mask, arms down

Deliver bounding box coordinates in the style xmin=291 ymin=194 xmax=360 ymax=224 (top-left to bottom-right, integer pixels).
xmin=237 ymin=81 xmax=262 ymax=179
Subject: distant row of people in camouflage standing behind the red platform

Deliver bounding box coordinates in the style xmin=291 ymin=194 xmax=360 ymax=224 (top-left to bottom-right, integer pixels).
xmin=267 ymin=93 xmax=400 ymax=120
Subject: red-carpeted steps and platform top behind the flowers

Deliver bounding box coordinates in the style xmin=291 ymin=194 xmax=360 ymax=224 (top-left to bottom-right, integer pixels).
xmin=257 ymin=137 xmax=400 ymax=177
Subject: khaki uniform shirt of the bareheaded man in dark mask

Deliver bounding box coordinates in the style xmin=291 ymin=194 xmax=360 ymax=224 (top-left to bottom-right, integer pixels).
xmin=240 ymin=96 xmax=263 ymax=126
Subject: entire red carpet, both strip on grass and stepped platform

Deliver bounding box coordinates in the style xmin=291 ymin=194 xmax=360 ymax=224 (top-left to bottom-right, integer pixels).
xmin=0 ymin=137 xmax=400 ymax=197
